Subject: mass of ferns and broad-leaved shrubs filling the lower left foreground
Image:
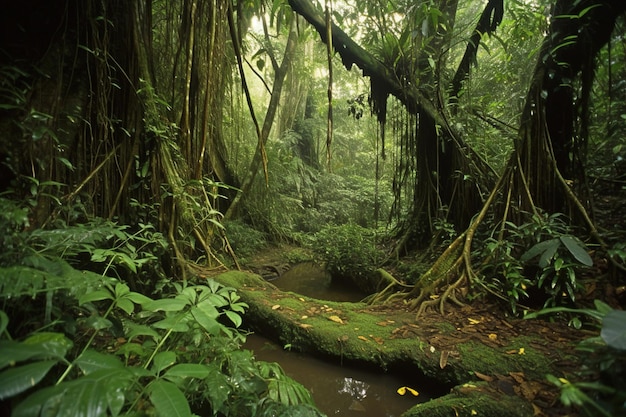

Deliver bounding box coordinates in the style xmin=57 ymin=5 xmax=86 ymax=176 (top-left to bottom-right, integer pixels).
xmin=0 ymin=198 xmax=321 ymax=417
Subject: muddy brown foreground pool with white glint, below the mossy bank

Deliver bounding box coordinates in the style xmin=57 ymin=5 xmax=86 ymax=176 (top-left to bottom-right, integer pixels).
xmin=244 ymin=335 xmax=429 ymax=417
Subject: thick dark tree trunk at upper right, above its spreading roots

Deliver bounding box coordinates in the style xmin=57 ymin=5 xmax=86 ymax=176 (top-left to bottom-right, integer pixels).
xmin=512 ymin=0 xmax=626 ymax=214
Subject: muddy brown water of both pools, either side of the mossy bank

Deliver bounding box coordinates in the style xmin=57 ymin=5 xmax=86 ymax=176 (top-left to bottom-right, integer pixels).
xmin=244 ymin=263 xmax=430 ymax=417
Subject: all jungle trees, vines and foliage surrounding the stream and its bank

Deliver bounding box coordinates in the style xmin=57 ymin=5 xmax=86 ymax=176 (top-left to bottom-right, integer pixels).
xmin=0 ymin=0 xmax=626 ymax=416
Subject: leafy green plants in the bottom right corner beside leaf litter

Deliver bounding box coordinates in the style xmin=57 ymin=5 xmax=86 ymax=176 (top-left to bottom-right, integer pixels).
xmin=525 ymin=300 xmax=626 ymax=417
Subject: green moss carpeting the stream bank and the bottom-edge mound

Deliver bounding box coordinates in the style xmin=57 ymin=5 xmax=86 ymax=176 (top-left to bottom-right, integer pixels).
xmin=216 ymin=272 xmax=566 ymax=417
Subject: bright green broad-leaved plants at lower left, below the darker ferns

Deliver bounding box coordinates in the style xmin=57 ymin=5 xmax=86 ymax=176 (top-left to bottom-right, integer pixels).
xmin=0 ymin=274 xmax=320 ymax=416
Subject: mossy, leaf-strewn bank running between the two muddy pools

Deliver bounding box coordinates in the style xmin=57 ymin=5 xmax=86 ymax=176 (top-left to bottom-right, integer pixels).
xmin=207 ymin=271 xmax=577 ymax=417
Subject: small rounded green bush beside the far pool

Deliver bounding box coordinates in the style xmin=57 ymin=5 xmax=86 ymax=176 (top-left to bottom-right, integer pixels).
xmin=312 ymin=224 xmax=382 ymax=281
